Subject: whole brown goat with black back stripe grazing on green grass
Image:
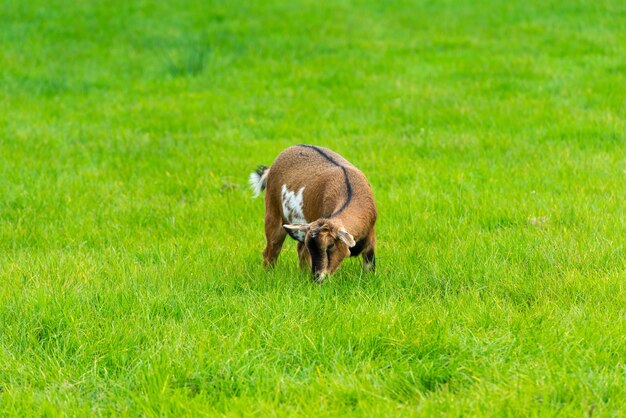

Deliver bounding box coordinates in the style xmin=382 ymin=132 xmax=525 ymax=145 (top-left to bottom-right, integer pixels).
xmin=250 ymin=145 xmax=377 ymax=283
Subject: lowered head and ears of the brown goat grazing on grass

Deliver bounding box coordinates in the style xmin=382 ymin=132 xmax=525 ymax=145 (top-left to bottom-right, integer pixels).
xmin=283 ymin=218 xmax=356 ymax=282
